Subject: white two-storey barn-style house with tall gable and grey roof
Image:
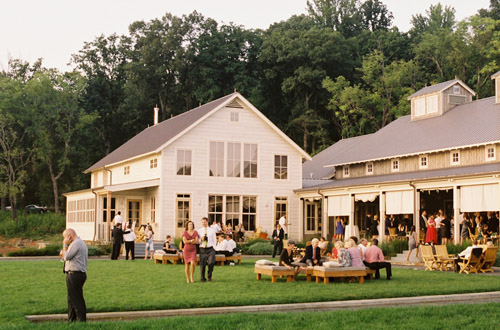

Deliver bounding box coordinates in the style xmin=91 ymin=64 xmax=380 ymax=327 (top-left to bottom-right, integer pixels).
xmin=65 ymin=92 xmax=311 ymax=241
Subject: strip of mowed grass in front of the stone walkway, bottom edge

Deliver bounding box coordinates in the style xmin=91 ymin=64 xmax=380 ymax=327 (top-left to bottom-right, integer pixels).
xmin=13 ymin=303 xmax=500 ymax=330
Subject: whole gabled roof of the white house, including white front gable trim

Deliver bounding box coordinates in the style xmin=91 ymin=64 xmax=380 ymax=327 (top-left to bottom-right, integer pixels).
xmin=84 ymin=92 xmax=311 ymax=173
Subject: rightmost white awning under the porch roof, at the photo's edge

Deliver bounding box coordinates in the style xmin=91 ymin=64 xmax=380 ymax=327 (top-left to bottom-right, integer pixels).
xmin=460 ymin=184 xmax=500 ymax=212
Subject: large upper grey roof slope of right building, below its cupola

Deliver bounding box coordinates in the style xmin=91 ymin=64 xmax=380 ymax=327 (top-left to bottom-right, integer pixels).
xmin=324 ymin=97 xmax=500 ymax=166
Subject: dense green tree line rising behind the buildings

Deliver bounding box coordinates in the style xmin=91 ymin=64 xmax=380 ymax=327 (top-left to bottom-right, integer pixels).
xmin=0 ymin=0 xmax=500 ymax=219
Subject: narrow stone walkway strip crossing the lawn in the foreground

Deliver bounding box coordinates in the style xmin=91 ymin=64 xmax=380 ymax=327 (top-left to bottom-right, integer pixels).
xmin=26 ymin=291 xmax=500 ymax=322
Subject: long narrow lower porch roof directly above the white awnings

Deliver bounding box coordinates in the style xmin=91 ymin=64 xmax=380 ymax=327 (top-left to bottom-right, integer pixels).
xmin=296 ymin=162 xmax=500 ymax=191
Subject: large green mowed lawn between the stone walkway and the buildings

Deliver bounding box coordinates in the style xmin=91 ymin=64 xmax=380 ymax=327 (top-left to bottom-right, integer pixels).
xmin=0 ymin=259 xmax=500 ymax=327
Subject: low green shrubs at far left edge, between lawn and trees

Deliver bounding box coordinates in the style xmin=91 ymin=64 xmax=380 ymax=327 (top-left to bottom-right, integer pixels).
xmin=0 ymin=211 xmax=66 ymax=239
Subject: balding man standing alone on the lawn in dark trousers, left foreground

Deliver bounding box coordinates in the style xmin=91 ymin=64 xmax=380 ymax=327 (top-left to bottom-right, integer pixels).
xmin=61 ymin=228 xmax=88 ymax=322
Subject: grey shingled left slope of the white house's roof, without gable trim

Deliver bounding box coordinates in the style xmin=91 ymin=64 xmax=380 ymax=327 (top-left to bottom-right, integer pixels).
xmin=85 ymin=93 xmax=237 ymax=172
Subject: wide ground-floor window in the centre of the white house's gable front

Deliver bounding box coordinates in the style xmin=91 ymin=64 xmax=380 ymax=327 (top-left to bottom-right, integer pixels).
xmin=208 ymin=195 xmax=257 ymax=231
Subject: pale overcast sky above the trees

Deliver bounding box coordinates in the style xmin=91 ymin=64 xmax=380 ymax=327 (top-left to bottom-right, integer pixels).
xmin=0 ymin=0 xmax=489 ymax=71
